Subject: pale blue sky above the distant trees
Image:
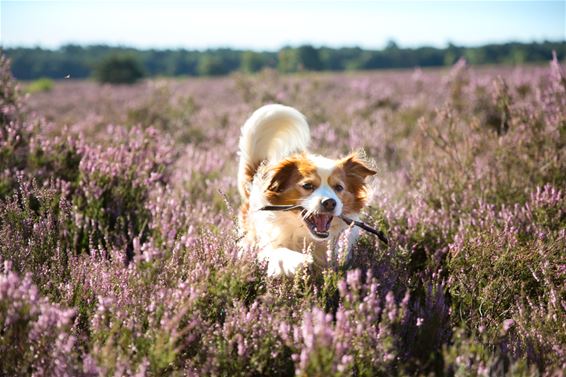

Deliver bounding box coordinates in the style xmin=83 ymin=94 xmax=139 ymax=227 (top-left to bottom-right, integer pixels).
xmin=0 ymin=0 xmax=566 ymax=50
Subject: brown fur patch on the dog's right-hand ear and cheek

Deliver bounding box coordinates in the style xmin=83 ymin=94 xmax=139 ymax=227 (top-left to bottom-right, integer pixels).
xmin=336 ymin=154 xmax=376 ymax=213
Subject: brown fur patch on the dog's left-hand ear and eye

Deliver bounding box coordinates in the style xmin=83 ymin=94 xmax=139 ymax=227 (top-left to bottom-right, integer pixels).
xmin=265 ymin=154 xmax=320 ymax=205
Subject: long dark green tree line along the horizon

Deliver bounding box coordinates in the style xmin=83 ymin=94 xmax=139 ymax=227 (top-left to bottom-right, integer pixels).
xmin=3 ymin=41 xmax=566 ymax=80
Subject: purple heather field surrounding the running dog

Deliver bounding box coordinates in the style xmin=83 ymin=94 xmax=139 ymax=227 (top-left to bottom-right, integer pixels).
xmin=0 ymin=53 xmax=566 ymax=376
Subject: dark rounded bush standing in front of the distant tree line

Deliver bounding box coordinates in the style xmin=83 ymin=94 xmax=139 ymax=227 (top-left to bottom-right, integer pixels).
xmin=95 ymin=55 xmax=144 ymax=84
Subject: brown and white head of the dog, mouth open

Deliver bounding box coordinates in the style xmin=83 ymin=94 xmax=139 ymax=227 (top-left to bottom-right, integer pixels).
xmin=265 ymin=153 xmax=375 ymax=241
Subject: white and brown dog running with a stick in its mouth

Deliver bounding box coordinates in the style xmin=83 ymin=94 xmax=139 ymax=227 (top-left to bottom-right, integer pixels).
xmin=238 ymin=104 xmax=376 ymax=276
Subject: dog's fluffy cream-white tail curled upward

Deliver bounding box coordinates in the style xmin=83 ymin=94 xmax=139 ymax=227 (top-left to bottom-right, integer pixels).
xmin=238 ymin=104 xmax=310 ymax=198
